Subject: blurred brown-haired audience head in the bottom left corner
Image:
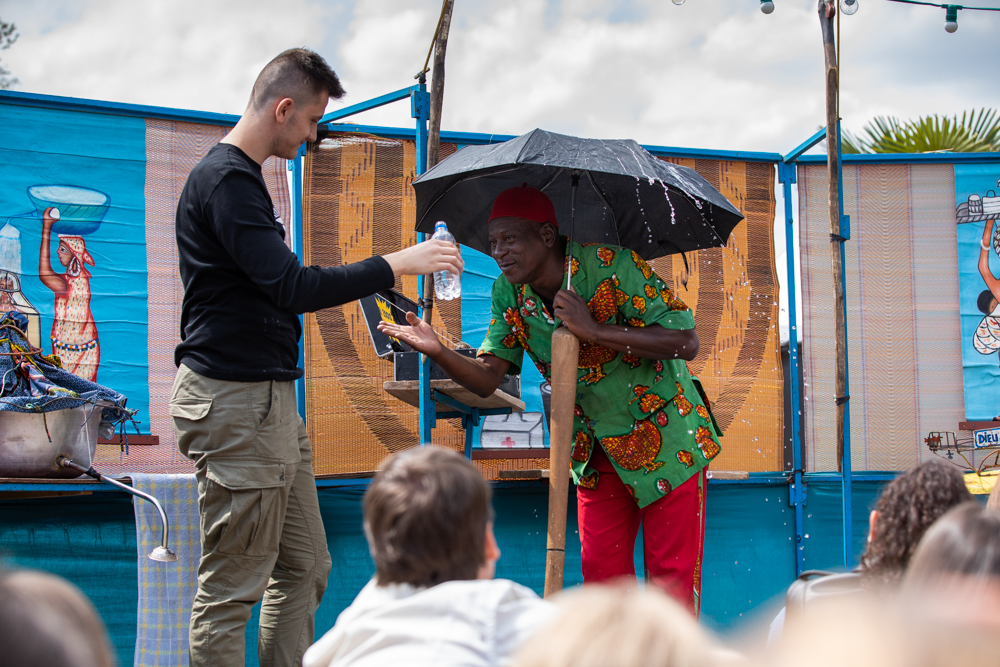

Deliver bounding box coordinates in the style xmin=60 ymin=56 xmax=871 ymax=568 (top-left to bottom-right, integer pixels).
xmin=0 ymin=571 xmax=115 ymax=667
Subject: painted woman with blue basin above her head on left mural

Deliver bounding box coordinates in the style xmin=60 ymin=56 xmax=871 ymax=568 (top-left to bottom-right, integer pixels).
xmin=0 ymin=185 xmax=111 ymax=382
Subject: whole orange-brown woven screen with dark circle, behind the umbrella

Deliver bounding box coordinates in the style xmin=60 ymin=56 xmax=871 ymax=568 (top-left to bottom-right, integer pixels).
xmin=303 ymin=135 xmax=783 ymax=478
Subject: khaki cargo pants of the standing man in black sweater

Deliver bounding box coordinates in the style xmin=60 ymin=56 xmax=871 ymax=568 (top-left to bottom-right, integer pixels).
xmin=170 ymin=364 xmax=330 ymax=667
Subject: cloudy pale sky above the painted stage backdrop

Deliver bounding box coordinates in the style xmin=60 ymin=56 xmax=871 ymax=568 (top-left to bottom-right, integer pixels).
xmin=0 ymin=0 xmax=1000 ymax=340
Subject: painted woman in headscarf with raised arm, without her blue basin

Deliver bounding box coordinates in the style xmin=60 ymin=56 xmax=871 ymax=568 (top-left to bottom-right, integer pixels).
xmin=38 ymin=208 xmax=101 ymax=382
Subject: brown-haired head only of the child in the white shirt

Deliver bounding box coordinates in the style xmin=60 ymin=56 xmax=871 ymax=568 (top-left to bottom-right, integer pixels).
xmin=364 ymin=446 xmax=500 ymax=586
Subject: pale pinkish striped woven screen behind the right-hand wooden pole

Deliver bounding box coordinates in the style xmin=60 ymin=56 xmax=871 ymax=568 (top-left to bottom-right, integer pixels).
xmin=798 ymin=164 xmax=964 ymax=471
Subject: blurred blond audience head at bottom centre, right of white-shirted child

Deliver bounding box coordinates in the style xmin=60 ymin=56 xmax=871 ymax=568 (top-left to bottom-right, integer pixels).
xmin=514 ymin=585 xmax=712 ymax=667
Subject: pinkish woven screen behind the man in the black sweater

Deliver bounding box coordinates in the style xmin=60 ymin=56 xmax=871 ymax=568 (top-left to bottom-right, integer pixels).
xmin=97 ymin=118 xmax=291 ymax=474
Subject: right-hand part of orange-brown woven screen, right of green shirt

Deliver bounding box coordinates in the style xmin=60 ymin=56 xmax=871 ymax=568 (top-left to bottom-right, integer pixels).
xmin=652 ymin=159 xmax=784 ymax=472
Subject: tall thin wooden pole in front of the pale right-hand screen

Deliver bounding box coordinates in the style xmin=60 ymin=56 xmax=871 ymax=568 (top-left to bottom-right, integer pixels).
xmin=819 ymin=0 xmax=847 ymax=472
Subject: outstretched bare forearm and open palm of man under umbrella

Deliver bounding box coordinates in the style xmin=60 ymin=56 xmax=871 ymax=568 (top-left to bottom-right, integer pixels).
xmin=378 ymin=313 xmax=510 ymax=398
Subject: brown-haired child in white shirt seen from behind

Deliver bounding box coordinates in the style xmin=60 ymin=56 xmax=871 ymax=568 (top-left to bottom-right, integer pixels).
xmin=303 ymin=446 xmax=553 ymax=667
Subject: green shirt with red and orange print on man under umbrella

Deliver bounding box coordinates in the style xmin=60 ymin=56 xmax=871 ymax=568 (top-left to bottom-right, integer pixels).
xmin=479 ymin=243 xmax=722 ymax=507
